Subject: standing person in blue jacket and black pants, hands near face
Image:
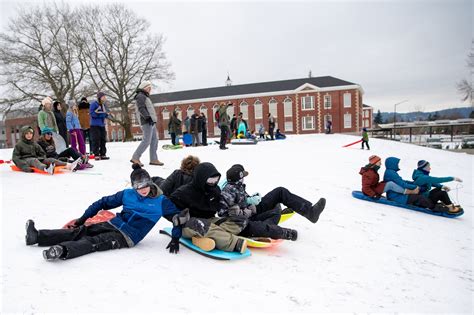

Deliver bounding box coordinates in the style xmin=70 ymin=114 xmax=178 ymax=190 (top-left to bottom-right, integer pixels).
xmin=89 ymin=92 xmax=109 ymax=161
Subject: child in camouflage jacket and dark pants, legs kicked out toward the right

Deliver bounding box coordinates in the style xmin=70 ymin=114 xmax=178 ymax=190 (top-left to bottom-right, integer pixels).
xmin=220 ymin=164 xmax=326 ymax=224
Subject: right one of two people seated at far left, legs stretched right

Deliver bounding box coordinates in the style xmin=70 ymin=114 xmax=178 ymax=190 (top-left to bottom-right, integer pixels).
xmin=37 ymin=127 xmax=94 ymax=169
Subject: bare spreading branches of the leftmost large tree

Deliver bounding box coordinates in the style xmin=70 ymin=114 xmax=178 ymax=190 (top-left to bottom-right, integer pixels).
xmin=0 ymin=4 xmax=87 ymax=113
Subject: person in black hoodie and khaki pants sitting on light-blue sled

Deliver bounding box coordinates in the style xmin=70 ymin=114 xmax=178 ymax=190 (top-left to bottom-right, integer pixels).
xmin=170 ymin=162 xmax=247 ymax=253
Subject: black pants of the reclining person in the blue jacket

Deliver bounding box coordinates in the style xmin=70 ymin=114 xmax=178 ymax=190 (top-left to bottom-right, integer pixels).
xmin=38 ymin=222 xmax=128 ymax=259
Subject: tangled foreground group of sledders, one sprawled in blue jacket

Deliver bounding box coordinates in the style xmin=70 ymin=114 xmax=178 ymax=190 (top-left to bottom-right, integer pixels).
xmin=25 ymin=156 xmax=326 ymax=260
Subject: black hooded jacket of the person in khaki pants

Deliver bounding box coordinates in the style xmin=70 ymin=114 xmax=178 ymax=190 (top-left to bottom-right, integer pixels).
xmin=170 ymin=162 xmax=221 ymax=219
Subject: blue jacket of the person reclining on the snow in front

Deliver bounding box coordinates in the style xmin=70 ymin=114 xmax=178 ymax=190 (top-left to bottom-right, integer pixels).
xmin=82 ymin=188 xmax=181 ymax=247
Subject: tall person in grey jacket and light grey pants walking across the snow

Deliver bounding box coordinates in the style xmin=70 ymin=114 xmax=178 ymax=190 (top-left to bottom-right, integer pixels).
xmin=130 ymin=81 xmax=164 ymax=166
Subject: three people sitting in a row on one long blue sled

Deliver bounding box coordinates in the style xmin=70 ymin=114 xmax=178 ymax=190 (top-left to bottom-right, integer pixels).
xmin=359 ymin=155 xmax=463 ymax=214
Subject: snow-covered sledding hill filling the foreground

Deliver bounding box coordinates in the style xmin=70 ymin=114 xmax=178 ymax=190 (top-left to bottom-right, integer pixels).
xmin=0 ymin=135 xmax=474 ymax=314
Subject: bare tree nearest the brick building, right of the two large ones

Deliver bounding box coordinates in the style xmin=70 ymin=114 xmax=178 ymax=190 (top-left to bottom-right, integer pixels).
xmin=79 ymin=4 xmax=174 ymax=140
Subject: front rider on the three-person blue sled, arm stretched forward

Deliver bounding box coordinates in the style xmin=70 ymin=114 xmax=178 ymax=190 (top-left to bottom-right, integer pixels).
xmin=412 ymin=160 xmax=462 ymax=213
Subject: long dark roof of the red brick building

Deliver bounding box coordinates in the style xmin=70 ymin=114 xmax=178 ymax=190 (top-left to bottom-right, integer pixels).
xmin=151 ymin=76 xmax=356 ymax=103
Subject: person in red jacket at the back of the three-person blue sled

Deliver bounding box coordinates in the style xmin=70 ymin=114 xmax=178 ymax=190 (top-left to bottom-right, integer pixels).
xmin=359 ymin=155 xmax=420 ymax=199
